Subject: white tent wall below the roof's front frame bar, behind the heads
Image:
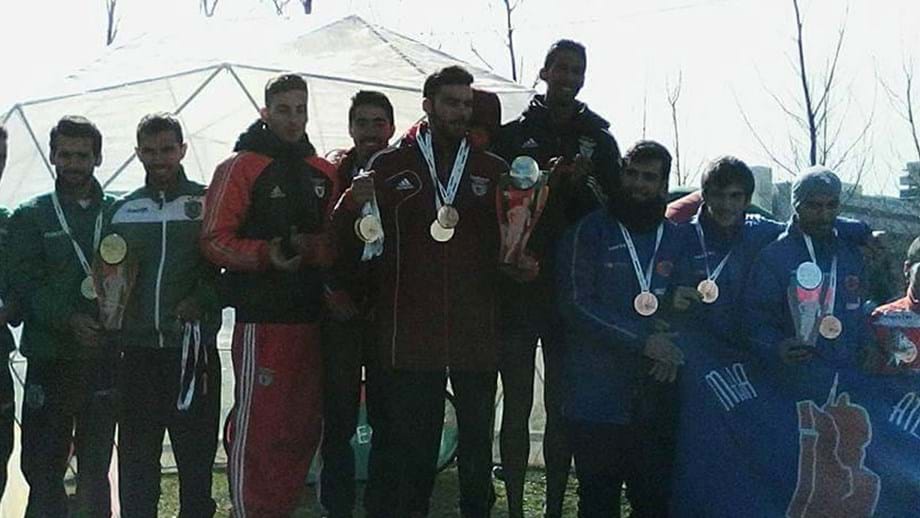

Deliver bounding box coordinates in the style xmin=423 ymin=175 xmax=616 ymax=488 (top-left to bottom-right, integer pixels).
xmin=0 ymin=67 xmax=530 ymax=207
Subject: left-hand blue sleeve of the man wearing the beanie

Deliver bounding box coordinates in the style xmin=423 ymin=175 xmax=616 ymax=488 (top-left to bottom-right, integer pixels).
xmin=744 ymin=254 xmax=788 ymax=357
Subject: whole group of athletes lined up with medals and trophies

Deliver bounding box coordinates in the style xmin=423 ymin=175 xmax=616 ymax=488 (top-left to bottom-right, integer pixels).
xmin=0 ymin=36 xmax=920 ymax=518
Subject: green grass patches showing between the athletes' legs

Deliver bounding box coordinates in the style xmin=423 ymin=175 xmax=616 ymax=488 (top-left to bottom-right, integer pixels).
xmin=159 ymin=467 xmax=577 ymax=518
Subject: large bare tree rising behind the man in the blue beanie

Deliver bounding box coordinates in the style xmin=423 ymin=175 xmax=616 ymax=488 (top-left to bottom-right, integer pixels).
xmin=741 ymin=0 xmax=874 ymax=183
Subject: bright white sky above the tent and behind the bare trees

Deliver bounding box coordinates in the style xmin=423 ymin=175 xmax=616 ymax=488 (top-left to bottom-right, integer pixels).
xmin=0 ymin=0 xmax=920 ymax=194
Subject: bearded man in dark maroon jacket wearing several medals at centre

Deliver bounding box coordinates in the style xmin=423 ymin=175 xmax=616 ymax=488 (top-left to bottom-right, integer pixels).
xmin=334 ymin=66 xmax=508 ymax=518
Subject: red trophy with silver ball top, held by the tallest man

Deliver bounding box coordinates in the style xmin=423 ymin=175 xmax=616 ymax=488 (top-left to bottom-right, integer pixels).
xmin=497 ymin=156 xmax=549 ymax=271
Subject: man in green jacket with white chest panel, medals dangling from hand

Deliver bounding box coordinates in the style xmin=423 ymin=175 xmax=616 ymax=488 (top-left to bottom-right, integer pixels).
xmin=100 ymin=114 xmax=220 ymax=518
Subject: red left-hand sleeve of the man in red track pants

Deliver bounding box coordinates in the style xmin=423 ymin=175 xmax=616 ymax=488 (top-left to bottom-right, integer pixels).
xmin=199 ymin=153 xmax=269 ymax=271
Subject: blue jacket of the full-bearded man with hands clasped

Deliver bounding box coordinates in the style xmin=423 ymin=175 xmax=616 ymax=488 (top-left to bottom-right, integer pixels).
xmin=556 ymin=209 xmax=679 ymax=424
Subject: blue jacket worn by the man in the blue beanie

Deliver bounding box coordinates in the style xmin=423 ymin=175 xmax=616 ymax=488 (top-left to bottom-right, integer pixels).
xmin=744 ymin=219 xmax=870 ymax=367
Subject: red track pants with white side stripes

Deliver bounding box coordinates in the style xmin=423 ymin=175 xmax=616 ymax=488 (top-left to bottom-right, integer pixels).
xmin=226 ymin=322 xmax=322 ymax=518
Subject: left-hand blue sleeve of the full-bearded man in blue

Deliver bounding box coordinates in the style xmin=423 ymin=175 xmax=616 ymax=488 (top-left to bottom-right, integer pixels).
xmin=556 ymin=217 xmax=648 ymax=352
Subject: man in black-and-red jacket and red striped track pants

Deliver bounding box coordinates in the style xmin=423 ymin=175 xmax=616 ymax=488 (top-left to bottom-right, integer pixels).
xmin=201 ymin=75 xmax=337 ymax=518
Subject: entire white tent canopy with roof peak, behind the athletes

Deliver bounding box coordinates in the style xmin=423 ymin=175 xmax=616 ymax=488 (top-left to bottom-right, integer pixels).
xmin=0 ymin=16 xmax=533 ymax=207
